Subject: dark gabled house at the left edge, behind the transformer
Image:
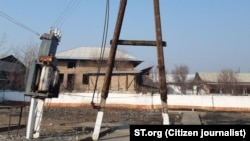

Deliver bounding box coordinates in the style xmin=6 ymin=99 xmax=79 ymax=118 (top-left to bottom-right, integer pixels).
xmin=0 ymin=55 xmax=26 ymax=90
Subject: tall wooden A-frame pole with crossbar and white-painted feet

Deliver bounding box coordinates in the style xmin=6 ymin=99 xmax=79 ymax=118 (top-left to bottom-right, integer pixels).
xmin=92 ymin=0 xmax=169 ymax=140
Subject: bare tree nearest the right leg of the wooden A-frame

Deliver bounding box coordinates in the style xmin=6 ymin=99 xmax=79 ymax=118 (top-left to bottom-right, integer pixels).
xmin=172 ymin=65 xmax=189 ymax=94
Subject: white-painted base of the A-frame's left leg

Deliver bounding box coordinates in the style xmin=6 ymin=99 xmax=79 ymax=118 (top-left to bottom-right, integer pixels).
xmin=92 ymin=111 xmax=103 ymax=141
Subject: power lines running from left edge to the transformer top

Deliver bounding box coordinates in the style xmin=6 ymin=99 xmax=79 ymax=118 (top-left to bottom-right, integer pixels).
xmin=0 ymin=11 xmax=41 ymax=36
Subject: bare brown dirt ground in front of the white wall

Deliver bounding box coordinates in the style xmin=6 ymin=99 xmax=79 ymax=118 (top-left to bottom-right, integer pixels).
xmin=0 ymin=106 xmax=250 ymax=141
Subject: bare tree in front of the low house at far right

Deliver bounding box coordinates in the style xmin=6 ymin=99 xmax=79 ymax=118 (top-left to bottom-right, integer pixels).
xmin=218 ymin=69 xmax=238 ymax=94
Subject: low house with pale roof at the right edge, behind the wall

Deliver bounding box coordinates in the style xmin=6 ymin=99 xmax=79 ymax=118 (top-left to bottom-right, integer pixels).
xmin=193 ymin=72 xmax=250 ymax=94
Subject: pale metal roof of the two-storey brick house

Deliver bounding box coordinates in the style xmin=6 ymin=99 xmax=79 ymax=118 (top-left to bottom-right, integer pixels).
xmin=56 ymin=47 xmax=142 ymax=62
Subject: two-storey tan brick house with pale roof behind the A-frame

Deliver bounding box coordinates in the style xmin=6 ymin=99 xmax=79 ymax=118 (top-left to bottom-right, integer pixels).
xmin=56 ymin=47 xmax=158 ymax=93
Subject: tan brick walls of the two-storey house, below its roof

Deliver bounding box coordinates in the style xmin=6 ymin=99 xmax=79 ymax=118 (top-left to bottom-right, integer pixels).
xmin=57 ymin=60 xmax=135 ymax=92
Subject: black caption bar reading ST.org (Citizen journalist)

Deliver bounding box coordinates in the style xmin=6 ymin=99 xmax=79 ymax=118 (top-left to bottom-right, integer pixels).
xmin=130 ymin=125 xmax=250 ymax=141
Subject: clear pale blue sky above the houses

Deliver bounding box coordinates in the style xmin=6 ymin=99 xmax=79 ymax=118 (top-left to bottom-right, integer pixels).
xmin=0 ymin=0 xmax=250 ymax=73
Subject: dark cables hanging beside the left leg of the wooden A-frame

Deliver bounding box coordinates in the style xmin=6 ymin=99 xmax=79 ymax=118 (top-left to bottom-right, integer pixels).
xmin=91 ymin=0 xmax=109 ymax=108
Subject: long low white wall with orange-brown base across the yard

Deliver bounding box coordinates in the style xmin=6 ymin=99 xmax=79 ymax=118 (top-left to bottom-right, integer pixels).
xmin=0 ymin=91 xmax=250 ymax=112
